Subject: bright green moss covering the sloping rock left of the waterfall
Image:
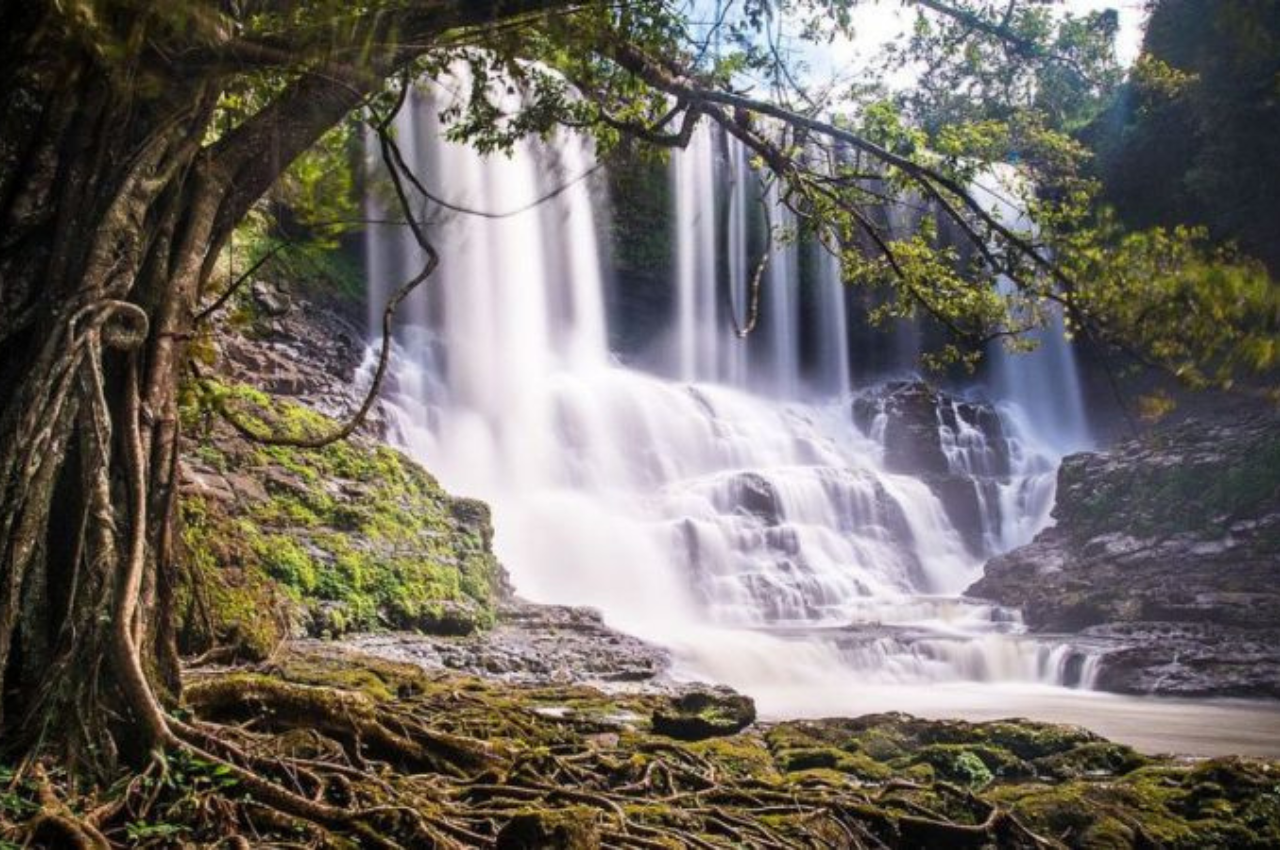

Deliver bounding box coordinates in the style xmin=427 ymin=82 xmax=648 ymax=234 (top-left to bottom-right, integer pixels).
xmin=184 ymin=381 xmax=503 ymax=655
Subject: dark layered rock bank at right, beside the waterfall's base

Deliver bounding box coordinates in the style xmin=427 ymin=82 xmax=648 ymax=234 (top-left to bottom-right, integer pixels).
xmin=968 ymin=413 xmax=1280 ymax=696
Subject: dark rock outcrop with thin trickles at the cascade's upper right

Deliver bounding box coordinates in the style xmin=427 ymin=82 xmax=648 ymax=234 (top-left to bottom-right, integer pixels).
xmin=852 ymin=381 xmax=1011 ymax=554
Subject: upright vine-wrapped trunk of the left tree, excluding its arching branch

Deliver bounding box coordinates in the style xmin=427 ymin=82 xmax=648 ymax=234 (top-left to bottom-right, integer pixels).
xmin=0 ymin=13 xmax=212 ymax=767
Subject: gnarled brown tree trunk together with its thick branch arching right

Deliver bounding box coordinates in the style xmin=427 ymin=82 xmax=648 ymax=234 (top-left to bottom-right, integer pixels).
xmin=0 ymin=0 xmax=570 ymax=771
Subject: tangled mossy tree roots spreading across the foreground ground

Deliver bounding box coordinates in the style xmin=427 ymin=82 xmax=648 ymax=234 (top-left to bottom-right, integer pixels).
xmin=0 ymin=653 xmax=1080 ymax=850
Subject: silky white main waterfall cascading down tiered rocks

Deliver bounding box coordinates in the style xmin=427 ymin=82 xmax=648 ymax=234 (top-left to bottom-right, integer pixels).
xmin=366 ymin=79 xmax=1088 ymax=706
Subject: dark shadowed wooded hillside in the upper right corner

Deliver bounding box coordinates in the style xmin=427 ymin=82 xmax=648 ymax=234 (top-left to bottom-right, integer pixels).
xmin=1083 ymin=0 xmax=1280 ymax=273
